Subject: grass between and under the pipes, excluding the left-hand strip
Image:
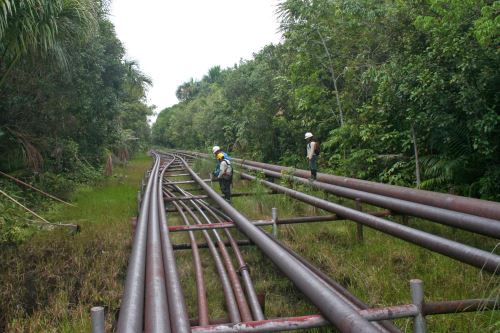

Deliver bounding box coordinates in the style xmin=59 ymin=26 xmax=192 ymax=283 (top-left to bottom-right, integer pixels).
xmin=185 ymin=157 xmax=500 ymax=333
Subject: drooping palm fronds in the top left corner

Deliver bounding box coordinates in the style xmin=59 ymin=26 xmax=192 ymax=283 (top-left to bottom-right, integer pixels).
xmin=0 ymin=0 xmax=100 ymax=86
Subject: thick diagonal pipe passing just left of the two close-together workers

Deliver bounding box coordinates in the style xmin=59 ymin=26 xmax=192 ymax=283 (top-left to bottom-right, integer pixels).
xmin=181 ymin=159 xmax=379 ymax=333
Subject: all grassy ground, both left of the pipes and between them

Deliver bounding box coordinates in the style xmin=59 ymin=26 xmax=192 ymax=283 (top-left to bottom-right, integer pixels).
xmin=0 ymin=156 xmax=500 ymax=333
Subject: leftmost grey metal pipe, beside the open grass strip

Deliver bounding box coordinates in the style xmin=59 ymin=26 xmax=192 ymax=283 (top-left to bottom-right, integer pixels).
xmin=117 ymin=154 xmax=160 ymax=333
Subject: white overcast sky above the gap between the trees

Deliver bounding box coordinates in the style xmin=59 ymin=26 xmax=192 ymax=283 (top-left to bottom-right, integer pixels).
xmin=110 ymin=0 xmax=280 ymax=122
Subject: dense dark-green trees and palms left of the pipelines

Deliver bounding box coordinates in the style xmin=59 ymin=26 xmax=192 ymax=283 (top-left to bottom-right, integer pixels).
xmin=0 ymin=0 xmax=152 ymax=244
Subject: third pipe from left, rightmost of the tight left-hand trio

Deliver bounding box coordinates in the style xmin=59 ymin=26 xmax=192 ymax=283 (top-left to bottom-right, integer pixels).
xmin=157 ymin=160 xmax=191 ymax=333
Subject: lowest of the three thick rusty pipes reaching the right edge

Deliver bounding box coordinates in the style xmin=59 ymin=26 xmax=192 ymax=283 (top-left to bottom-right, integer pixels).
xmin=241 ymin=173 xmax=500 ymax=274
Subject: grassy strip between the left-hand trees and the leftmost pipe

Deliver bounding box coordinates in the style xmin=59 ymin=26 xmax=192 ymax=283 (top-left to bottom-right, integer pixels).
xmin=0 ymin=155 xmax=151 ymax=332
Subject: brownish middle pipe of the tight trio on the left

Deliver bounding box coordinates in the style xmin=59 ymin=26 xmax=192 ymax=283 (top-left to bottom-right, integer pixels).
xmin=144 ymin=154 xmax=172 ymax=333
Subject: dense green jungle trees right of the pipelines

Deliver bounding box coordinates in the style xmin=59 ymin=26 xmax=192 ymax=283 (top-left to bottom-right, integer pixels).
xmin=153 ymin=0 xmax=500 ymax=200
